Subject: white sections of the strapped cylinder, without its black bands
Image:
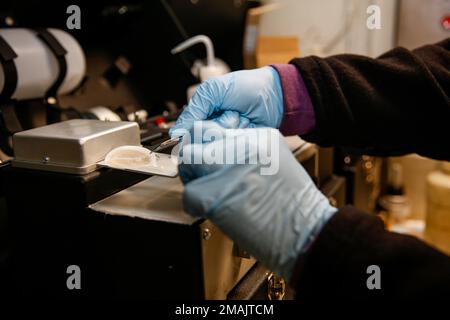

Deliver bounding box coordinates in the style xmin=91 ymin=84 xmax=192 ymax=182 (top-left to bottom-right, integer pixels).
xmin=0 ymin=28 xmax=86 ymax=100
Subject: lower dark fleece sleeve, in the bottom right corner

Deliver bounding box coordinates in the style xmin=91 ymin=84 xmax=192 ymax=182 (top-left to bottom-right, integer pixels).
xmin=292 ymin=206 xmax=450 ymax=300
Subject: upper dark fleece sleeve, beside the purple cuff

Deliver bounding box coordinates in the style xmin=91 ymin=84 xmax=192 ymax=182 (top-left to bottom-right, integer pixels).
xmin=291 ymin=39 xmax=450 ymax=159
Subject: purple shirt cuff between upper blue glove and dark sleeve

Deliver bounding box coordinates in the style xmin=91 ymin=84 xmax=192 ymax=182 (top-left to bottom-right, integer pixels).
xmin=272 ymin=64 xmax=316 ymax=136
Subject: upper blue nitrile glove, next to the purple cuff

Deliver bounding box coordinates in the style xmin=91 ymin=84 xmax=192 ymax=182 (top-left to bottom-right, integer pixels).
xmin=170 ymin=67 xmax=283 ymax=137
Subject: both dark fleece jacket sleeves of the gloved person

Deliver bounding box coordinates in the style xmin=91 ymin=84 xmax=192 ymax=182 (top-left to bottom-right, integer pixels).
xmin=291 ymin=39 xmax=450 ymax=299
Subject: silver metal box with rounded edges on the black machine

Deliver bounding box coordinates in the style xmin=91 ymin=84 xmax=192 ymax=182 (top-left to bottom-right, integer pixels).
xmin=12 ymin=119 xmax=141 ymax=174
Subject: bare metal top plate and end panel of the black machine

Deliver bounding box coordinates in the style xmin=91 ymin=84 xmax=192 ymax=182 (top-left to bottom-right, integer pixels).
xmin=89 ymin=177 xmax=255 ymax=299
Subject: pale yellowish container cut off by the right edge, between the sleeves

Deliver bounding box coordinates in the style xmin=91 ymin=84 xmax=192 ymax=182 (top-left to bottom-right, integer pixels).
xmin=425 ymin=162 xmax=450 ymax=254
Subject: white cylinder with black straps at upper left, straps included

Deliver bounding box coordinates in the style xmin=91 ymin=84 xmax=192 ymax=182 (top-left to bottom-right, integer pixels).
xmin=0 ymin=28 xmax=86 ymax=100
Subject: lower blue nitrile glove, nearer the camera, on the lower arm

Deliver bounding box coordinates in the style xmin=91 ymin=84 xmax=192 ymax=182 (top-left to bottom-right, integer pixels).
xmin=179 ymin=121 xmax=337 ymax=279
